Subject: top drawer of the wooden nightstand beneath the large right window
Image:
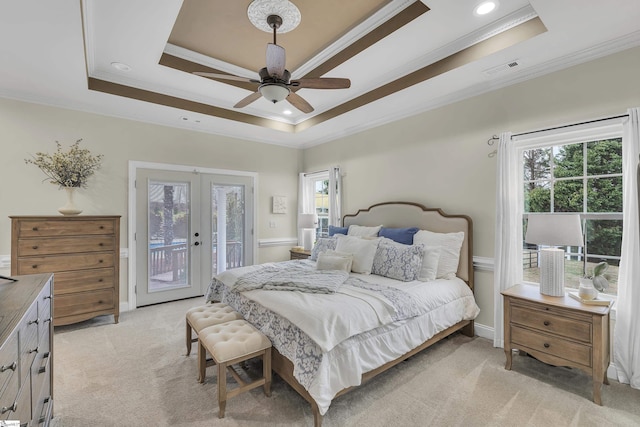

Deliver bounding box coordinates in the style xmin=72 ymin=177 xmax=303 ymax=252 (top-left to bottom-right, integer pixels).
xmin=511 ymin=305 xmax=592 ymax=343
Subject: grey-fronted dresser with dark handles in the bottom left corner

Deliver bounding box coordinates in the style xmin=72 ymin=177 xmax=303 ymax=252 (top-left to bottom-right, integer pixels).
xmin=0 ymin=274 xmax=53 ymax=427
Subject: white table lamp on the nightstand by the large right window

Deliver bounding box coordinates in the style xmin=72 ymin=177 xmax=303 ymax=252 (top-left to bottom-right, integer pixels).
xmin=524 ymin=214 xmax=584 ymax=297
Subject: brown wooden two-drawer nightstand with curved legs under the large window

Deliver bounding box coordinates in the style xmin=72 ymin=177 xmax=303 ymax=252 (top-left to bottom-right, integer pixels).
xmin=502 ymin=285 xmax=609 ymax=405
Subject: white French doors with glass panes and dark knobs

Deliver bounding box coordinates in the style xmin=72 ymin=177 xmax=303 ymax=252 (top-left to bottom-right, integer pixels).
xmin=135 ymin=168 xmax=254 ymax=307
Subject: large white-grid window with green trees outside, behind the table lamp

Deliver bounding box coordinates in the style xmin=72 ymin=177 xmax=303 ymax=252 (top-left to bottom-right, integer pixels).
xmin=522 ymin=135 xmax=622 ymax=295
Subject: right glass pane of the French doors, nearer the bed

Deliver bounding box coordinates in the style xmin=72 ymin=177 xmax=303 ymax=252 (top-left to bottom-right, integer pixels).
xmin=211 ymin=184 xmax=245 ymax=273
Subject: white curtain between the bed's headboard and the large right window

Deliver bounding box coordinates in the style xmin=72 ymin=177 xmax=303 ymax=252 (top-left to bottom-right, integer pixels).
xmin=493 ymin=132 xmax=523 ymax=347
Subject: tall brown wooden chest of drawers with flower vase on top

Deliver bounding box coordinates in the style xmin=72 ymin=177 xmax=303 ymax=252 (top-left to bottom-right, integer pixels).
xmin=11 ymin=215 xmax=120 ymax=326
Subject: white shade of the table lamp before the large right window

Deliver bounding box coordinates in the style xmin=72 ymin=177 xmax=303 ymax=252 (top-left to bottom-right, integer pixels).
xmin=524 ymin=214 xmax=584 ymax=246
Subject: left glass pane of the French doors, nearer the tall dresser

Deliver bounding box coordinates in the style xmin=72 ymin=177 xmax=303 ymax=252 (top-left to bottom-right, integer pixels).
xmin=148 ymin=181 xmax=190 ymax=292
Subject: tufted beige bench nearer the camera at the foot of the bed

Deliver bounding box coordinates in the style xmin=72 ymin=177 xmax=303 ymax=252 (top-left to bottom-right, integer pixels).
xmin=198 ymin=320 xmax=271 ymax=418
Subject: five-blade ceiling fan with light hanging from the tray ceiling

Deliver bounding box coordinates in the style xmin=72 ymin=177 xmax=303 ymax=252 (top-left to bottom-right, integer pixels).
xmin=193 ymin=15 xmax=351 ymax=113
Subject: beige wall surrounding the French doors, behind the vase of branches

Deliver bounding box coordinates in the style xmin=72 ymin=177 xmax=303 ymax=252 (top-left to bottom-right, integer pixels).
xmin=0 ymin=99 xmax=301 ymax=301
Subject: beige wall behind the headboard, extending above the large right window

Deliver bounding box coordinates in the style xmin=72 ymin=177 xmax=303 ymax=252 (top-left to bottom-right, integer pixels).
xmin=303 ymin=48 xmax=640 ymax=327
